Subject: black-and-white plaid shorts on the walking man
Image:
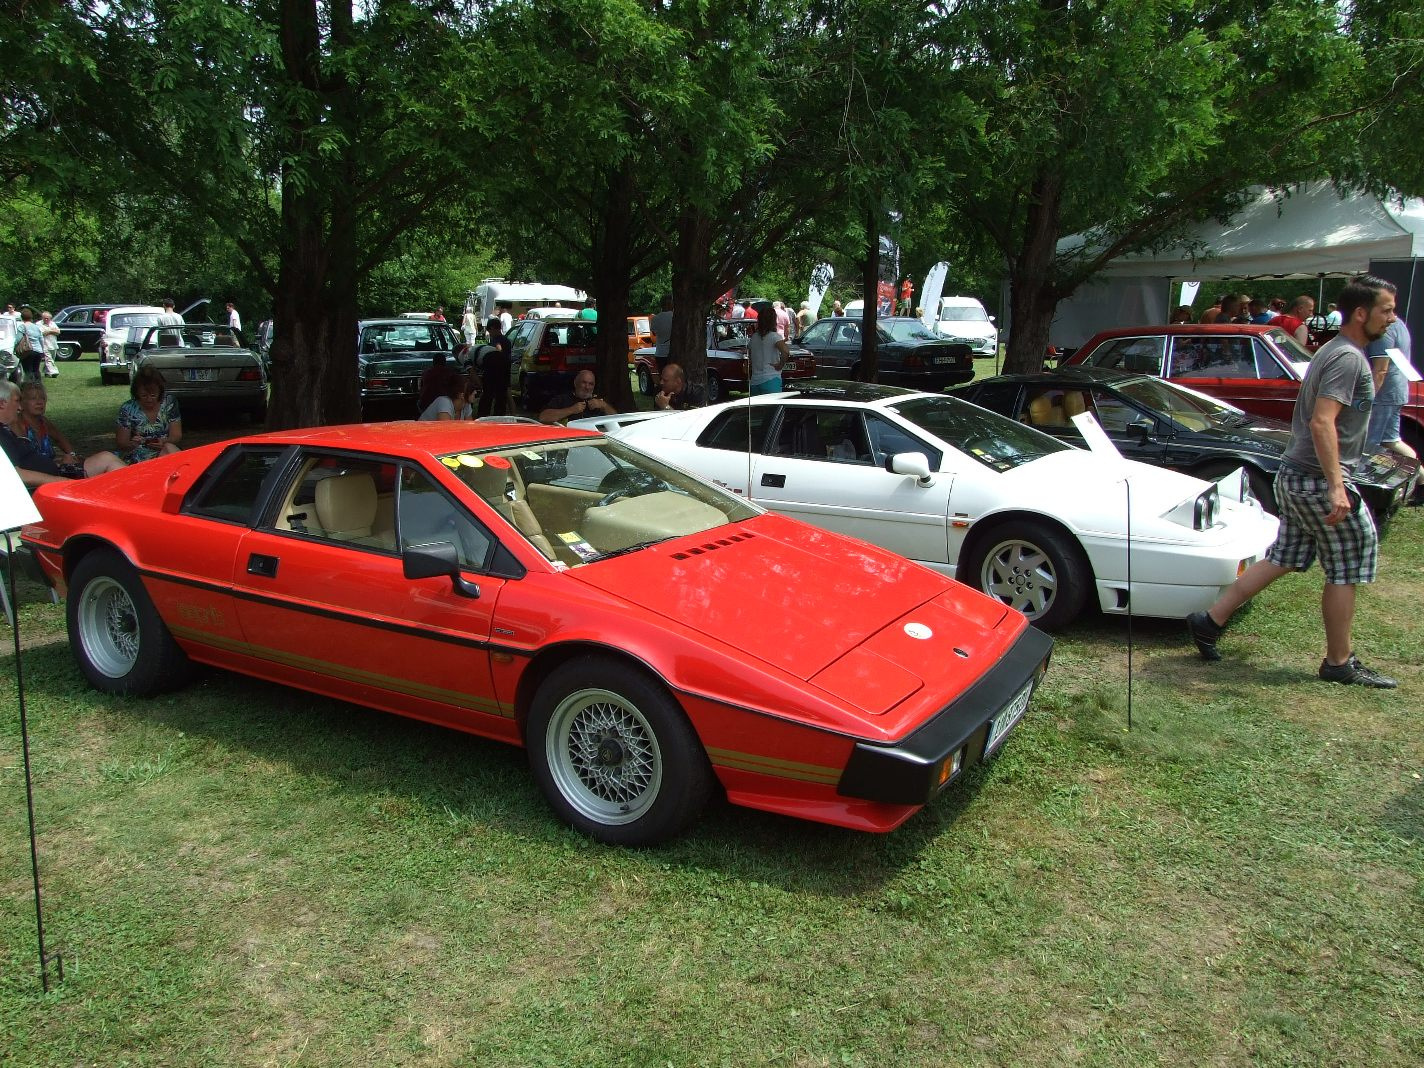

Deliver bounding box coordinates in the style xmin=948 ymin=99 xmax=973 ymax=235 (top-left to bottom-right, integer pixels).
xmin=1266 ymin=467 xmax=1380 ymax=585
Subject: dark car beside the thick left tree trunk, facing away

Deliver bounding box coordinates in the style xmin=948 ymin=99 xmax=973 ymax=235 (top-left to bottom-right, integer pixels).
xmin=356 ymin=318 xmax=463 ymax=420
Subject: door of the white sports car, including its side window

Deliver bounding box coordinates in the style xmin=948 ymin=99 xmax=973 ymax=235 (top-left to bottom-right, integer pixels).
xmin=752 ymin=404 xmax=953 ymax=565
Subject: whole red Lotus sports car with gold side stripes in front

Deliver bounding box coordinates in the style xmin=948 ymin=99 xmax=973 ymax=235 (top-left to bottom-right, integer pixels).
xmin=23 ymin=422 xmax=1051 ymax=844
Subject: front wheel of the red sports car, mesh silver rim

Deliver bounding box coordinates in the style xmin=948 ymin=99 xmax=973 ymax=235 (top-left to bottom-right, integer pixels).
xmin=525 ymin=656 xmax=715 ymax=846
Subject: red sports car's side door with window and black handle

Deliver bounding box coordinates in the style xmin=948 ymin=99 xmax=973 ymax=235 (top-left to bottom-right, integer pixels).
xmin=232 ymin=450 xmax=515 ymax=736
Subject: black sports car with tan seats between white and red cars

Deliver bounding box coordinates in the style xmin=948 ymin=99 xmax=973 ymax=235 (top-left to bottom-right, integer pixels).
xmin=951 ymin=367 xmax=1417 ymax=527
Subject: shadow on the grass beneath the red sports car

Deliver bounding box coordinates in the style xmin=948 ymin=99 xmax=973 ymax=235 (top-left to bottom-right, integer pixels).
xmin=8 ymin=641 xmax=988 ymax=896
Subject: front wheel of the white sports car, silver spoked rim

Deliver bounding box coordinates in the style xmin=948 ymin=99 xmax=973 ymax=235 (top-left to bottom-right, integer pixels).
xmin=957 ymin=520 xmax=1092 ymax=631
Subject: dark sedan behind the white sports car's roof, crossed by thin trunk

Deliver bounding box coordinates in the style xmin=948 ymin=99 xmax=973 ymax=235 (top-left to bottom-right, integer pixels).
xmin=796 ymin=315 xmax=974 ymax=392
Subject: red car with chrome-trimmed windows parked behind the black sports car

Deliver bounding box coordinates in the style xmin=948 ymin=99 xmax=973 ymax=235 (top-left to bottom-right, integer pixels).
xmin=1068 ymin=323 xmax=1424 ymax=454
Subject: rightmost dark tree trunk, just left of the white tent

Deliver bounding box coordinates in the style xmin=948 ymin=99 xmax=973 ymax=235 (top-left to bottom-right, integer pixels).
xmin=1004 ymin=171 xmax=1062 ymax=375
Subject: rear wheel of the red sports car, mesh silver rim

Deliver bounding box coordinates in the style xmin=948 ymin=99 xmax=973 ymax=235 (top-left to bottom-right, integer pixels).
xmin=66 ymin=550 xmax=192 ymax=696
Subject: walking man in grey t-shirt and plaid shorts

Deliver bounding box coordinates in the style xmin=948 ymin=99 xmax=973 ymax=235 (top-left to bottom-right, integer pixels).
xmin=1186 ymin=275 xmax=1398 ymax=689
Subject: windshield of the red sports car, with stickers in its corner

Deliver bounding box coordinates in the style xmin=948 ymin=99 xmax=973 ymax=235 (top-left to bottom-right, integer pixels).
xmin=440 ymin=437 xmax=759 ymax=567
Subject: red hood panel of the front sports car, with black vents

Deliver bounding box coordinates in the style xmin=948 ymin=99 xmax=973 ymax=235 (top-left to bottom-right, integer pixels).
xmin=568 ymin=515 xmax=1007 ymax=679
